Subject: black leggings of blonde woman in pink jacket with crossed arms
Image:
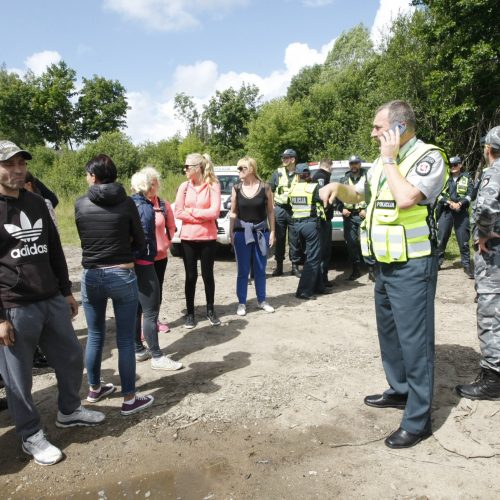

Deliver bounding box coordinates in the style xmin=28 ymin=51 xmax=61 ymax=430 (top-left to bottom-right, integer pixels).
xmin=182 ymin=240 xmax=216 ymax=314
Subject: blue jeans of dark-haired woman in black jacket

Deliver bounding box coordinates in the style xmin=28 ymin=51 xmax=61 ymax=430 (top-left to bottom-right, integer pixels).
xmin=82 ymin=267 xmax=138 ymax=396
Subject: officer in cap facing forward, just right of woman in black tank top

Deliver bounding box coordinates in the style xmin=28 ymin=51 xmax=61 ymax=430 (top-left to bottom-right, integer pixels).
xmin=269 ymin=149 xmax=301 ymax=278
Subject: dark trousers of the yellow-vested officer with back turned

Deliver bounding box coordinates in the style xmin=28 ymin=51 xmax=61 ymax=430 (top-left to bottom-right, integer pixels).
xmin=294 ymin=217 xmax=325 ymax=297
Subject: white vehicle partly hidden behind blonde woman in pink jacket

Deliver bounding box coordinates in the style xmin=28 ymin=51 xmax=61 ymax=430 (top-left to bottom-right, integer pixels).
xmin=170 ymin=165 xmax=240 ymax=256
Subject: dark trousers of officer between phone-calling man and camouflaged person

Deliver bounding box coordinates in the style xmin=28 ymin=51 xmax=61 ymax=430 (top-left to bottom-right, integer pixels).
xmin=438 ymin=209 xmax=470 ymax=269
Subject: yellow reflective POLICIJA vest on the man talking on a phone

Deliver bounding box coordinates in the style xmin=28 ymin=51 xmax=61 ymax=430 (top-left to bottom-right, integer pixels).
xmin=360 ymin=144 xmax=448 ymax=263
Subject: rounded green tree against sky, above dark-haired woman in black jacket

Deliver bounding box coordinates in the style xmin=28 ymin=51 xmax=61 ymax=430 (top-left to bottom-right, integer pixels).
xmin=75 ymin=75 xmax=128 ymax=142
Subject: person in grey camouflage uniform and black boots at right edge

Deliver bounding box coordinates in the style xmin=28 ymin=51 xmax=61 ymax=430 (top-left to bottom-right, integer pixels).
xmin=456 ymin=126 xmax=500 ymax=401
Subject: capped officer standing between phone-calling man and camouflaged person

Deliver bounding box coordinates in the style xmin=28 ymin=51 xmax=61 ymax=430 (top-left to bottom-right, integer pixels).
xmin=436 ymin=156 xmax=474 ymax=279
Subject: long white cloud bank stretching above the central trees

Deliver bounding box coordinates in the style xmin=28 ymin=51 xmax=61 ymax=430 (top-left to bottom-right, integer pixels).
xmin=126 ymin=36 xmax=335 ymax=143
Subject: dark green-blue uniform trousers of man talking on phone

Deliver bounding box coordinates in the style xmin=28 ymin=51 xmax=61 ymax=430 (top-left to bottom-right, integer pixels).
xmin=375 ymin=255 xmax=437 ymax=434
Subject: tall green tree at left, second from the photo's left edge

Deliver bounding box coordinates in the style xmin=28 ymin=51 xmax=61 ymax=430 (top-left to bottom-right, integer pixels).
xmin=31 ymin=61 xmax=76 ymax=149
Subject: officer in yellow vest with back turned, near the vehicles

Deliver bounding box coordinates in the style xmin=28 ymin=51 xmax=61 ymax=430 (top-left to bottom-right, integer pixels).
xmin=288 ymin=163 xmax=327 ymax=300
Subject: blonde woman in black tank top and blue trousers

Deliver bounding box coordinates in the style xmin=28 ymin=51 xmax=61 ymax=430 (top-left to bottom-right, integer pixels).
xmin=229 ymin=156 xmax=274 ymax=316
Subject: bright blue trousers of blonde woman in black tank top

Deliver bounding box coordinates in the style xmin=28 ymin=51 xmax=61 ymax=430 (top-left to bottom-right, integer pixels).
xmin=234 ymin=231 xmax=269 ymax=304
